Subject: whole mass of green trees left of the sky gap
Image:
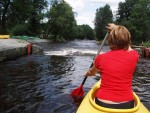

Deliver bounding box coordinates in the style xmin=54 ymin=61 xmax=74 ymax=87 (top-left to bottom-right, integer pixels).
xmin=0 ymin=0 xmax=94 ymax=41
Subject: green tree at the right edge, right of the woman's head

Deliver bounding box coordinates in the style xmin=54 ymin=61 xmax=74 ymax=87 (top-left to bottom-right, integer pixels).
xmin=129 ymin=0 xmax=150 ymax=41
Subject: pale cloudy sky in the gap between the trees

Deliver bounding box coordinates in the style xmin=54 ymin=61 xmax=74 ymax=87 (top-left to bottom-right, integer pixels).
xmin=65 ymin=0 xmax=125 ymax=28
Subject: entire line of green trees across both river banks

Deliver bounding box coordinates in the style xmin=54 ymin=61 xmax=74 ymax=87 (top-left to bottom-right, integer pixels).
xmin=0 ymin=0 xmax=150 ymax=43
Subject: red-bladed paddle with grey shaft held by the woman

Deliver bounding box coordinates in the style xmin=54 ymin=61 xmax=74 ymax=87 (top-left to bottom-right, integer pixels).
xmin=71 ymin=33 xmax=108 ymax=98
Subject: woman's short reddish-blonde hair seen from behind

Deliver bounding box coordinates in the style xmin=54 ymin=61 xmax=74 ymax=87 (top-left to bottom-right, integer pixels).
xmin=108 ymin=25 xmax=131 ymax=50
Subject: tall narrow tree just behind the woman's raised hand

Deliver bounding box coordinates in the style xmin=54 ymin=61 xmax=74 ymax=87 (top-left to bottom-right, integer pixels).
xmin=94 ymin=4 xmax=113 ymax=40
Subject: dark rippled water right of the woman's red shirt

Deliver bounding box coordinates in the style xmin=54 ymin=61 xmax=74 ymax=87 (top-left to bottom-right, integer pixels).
xmin=133 ymin=59 xmax=150 ymax=110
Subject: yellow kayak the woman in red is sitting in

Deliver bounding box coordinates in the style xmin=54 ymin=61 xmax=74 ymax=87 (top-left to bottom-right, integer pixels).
xmin=76 ymin=82 xmax=150 ymax=113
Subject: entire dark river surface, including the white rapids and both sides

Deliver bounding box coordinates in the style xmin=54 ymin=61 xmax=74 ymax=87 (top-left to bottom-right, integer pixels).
xmin=0 ymin=40 xmax=150 ymax=113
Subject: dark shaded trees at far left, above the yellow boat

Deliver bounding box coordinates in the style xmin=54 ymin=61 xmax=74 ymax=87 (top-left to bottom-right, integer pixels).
xmin=0 ymin=0 xmax=47 ymax=36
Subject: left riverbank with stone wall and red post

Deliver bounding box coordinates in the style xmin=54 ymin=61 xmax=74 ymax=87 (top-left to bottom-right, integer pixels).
xmin=0 ymin=38 xmax=49 ymax=62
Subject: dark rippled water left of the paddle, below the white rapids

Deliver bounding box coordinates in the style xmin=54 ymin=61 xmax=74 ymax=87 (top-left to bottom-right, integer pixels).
xmin=0 ymin=55 xmax=94 ymax=113
